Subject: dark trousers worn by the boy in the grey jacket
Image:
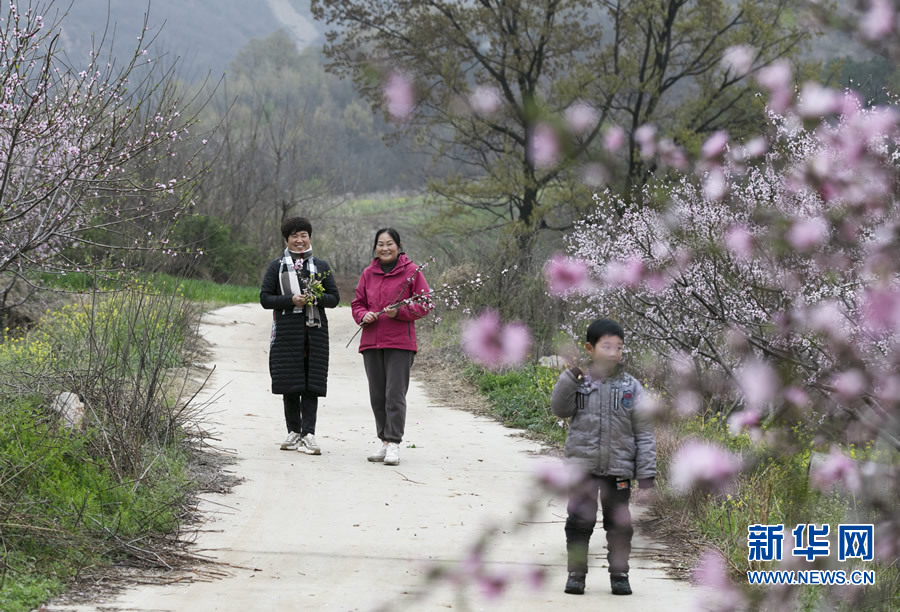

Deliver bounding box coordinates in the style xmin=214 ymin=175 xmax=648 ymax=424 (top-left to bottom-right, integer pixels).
xmin=566 ymin=474 xmax=634 ymax=573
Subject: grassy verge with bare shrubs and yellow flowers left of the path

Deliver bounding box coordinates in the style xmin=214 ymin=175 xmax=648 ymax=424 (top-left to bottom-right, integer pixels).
xmin=0 ymin=278 xmax=214 ymax=611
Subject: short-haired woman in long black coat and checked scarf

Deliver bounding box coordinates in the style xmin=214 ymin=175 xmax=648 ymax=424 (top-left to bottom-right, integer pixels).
xmin=259 ymin=217 xmax=340 ymax=455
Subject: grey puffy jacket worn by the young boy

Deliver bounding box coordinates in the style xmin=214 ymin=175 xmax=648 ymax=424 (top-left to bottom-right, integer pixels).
xmin=550 ymin=368 xmax=656 ymax=480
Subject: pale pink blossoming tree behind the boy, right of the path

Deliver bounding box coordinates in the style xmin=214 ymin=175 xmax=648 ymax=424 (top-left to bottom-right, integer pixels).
xmin=569 ymin=104 xmax=900 ymax=440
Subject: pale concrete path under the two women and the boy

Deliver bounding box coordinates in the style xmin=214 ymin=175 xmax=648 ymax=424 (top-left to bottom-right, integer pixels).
xmin=52 ymin=305 xmax=698 ymax=612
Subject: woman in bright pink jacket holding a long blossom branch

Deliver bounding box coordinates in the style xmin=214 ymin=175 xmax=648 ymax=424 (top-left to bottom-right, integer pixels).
xmin=351 ymin=228 xmax=429 ymax=465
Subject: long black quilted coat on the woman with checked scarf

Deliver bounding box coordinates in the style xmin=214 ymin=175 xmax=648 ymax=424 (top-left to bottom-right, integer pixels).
xmin=259 ymin=257 xmax=340 ymax=396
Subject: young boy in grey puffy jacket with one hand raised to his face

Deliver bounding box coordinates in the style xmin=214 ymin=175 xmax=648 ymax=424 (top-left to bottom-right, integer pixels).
xmin=550 ymin=319 xmax=656 ymax=595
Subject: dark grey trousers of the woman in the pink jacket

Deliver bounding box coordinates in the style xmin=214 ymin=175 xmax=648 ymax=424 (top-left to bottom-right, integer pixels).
xmin=363 ymin=349 xmax=416 ymax=444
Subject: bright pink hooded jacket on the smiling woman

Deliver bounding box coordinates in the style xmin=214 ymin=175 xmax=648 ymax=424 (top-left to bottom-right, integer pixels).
xmin=350 ymin=253 xmax=430 ymax=352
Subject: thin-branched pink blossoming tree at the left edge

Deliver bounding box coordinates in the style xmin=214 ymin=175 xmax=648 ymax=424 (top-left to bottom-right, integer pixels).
xmin=0 ymin=2 xmax=204 ymax=298
